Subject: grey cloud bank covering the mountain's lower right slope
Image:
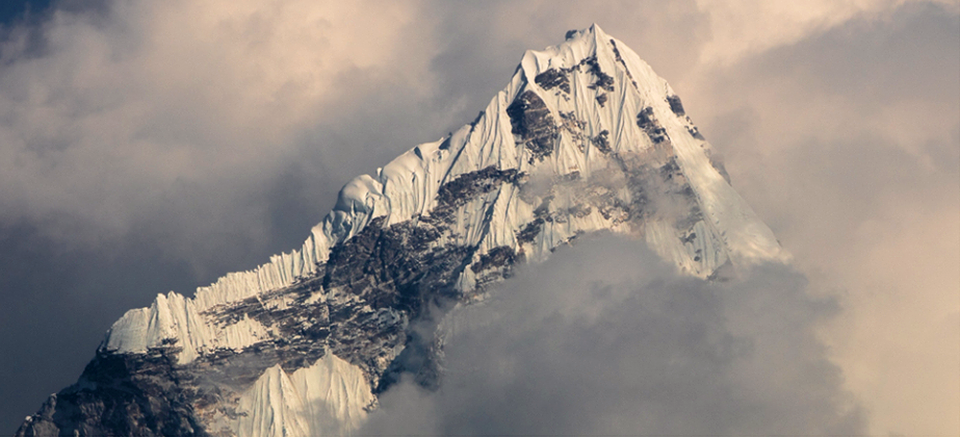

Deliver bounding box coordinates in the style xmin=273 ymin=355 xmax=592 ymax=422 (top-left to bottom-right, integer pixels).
xmin=360 ymin=237 xmax=865 ymax=435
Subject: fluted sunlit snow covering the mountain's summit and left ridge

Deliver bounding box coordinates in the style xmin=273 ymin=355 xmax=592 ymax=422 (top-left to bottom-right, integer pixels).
xmin=102 ymin=25 xmax=784 ymax=363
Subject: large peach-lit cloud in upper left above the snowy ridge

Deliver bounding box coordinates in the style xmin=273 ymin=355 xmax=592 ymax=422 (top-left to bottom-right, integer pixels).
xmin=0 ymin=1 xmax=440 ymax=266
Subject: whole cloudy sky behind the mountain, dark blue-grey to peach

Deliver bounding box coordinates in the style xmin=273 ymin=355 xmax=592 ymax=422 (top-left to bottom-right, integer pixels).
xmin=0 ymin=0 xmax=960 ymax=435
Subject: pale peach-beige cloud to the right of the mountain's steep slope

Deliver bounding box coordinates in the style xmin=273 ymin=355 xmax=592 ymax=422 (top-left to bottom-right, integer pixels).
xmin=682 ymin=4 xmax=960 ymax=434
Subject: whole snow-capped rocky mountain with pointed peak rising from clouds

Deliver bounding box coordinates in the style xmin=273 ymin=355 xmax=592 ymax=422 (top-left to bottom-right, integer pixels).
xmin=17 ymin=25 xmax=784 ymax=437
